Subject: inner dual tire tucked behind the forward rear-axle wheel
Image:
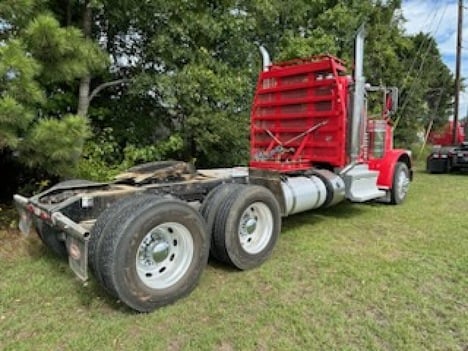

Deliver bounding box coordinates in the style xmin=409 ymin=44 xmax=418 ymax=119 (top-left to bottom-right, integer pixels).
xmin=200 ymin=183 xmax=242 ymax=262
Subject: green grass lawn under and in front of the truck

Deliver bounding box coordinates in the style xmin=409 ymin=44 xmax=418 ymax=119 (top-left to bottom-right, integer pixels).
xmin=0 ymin=168 xmax=468 ymax=351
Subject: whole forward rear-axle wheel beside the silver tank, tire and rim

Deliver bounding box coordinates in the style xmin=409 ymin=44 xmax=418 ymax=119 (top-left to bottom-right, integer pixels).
xmin=213 ymin=185 xmax=281 ymax=270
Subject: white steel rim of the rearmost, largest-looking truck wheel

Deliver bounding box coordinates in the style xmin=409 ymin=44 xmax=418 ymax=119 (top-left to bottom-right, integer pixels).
xmin=136 ymin=222 xmax=194 ymax=289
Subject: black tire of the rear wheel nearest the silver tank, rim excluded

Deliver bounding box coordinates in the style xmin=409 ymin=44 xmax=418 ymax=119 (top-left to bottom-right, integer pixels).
xmin=213 ymin=185 xmax=281 ymax=270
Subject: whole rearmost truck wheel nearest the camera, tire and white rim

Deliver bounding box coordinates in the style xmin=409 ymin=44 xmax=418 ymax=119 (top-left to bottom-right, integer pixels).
xmin=96 ymin=197 xmax=209 ymax=312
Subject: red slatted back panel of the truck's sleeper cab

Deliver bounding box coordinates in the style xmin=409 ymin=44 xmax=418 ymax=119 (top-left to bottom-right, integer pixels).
xmin=250 ymin=56 xmax=349 ymax=171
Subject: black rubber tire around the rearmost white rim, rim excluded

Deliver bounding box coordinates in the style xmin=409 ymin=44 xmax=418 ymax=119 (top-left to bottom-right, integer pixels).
xmin=96 ymin=197 xmax=209 ymax=312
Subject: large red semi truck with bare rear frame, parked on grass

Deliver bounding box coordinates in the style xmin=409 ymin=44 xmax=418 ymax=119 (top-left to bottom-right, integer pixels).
xmin=14 ymin=30 xmax=412 ymax=312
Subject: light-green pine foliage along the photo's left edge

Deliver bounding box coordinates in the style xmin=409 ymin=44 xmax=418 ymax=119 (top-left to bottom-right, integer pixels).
xmin=0 ymin=1 xmax=107 ymax=187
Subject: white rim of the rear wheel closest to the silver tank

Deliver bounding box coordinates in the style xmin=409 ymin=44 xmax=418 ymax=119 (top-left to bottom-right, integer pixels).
xmin=239 ymin=202 xmax=273 ymax=254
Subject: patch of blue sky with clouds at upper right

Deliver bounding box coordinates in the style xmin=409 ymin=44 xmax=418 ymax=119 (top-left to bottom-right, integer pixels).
xmin=402 ymin=0 xmax=468 ymax=117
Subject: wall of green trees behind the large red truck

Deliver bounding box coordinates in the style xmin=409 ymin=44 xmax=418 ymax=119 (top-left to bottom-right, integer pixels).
xmin=0 ymin=0 xmax=454 ymax=198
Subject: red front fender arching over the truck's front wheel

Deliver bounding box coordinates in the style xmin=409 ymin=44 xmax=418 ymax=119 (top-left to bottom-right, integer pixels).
xmin=369 ymin=149 xmax=413 ymax=189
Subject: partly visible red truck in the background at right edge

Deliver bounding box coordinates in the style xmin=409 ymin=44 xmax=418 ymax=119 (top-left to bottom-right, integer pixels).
xmin=426 ymin=121 xmax=468 ymax=173
